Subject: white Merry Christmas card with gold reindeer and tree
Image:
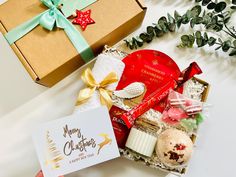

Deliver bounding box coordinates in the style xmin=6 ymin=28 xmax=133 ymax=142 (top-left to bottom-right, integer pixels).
xmin=33 ymin=107 xmax=120 ymax=177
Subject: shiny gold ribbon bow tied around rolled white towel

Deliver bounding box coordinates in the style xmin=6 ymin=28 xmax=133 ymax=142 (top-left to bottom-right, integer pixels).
xmin=76 ymin=68 xmax=118 ymax=109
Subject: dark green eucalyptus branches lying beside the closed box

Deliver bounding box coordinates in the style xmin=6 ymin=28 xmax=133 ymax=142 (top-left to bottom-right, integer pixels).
xmin=125 ymin=0 xmax=236 ymax=56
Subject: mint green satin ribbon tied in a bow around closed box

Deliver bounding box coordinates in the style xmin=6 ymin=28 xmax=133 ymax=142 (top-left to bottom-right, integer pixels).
xmin=5 ymin=0 xmax=94 ymax=63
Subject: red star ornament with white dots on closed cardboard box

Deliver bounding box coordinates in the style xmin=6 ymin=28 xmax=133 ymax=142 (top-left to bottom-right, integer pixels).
xmin=72 ymin=10 xmax=95 ymax=31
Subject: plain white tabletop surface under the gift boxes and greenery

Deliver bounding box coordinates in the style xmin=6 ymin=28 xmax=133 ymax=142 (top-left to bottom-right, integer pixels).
xmin=0 ymin=0 xmax=236 ymax=177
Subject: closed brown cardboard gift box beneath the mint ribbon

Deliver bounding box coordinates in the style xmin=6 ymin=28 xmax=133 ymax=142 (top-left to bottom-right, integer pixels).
xmin=0 ymin=0 xmax=146 ymax=87
